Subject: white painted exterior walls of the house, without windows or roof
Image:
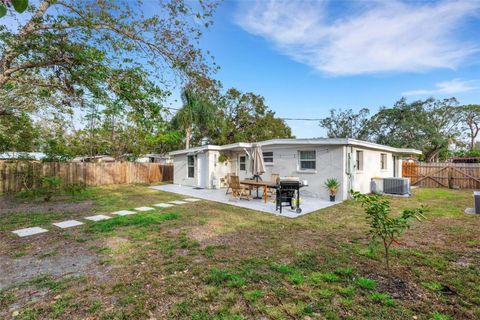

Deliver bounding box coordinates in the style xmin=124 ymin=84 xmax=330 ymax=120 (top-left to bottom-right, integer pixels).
xmin=173 ymin=145 xmax=402 ymax=200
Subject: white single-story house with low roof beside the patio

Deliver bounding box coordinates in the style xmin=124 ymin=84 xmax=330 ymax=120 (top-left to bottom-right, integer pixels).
xmin=170 ymin=138 xmax=421 ymax=200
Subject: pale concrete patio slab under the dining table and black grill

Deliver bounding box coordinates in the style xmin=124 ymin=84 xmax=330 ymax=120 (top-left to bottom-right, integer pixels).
xmin=150 ymin=184 xmax=339 ymax=218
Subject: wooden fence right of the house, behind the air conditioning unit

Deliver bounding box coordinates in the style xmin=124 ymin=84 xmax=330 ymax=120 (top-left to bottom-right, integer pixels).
xmin=402 ymin=162 xmax=480 ymax=189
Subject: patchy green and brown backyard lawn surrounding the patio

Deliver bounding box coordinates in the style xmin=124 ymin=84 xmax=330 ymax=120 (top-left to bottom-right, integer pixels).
xmin=0 ymin=185 xmax=480 ymax=320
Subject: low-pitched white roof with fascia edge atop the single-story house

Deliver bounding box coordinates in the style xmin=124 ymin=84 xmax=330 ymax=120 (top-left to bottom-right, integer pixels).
xmin=170 ymin=138 xmax=422 ymax=156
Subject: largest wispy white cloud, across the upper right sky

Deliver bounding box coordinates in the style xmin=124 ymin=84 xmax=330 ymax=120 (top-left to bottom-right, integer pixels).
xmin=236 ymin=0 xmax=480 ymax=75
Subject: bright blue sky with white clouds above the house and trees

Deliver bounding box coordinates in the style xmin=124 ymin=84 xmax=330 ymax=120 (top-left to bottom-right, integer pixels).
xmin=195 ymin=0 xmax=480 ymax=138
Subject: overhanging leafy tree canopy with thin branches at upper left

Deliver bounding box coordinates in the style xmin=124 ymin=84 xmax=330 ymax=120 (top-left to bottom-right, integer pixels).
xmin=0 ymin=0 xmax=215 ymax=115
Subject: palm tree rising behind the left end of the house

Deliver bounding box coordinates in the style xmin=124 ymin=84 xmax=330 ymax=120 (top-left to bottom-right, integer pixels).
xmin=172 ymin=86 xmax=217 ymax=149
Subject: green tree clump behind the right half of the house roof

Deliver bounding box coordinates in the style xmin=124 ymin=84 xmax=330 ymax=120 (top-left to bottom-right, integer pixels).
xmin=320 ymin=98 xmax=465 ymax=161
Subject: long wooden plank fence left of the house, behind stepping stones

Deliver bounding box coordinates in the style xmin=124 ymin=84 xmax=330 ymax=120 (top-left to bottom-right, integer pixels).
xmin=0 ymin=161 xmax=173 ymax=193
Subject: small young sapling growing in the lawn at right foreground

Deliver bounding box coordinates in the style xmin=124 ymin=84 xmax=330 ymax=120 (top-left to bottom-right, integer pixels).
xmin=353 ymin=192 xmax=426 ymax=271
